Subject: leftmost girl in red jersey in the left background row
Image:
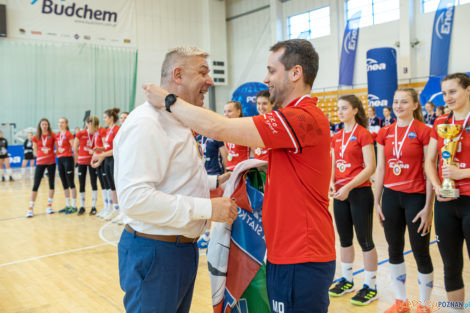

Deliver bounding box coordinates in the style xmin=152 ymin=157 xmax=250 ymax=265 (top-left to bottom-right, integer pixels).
xmin=26 ymin=118 xmax=56 ymax=217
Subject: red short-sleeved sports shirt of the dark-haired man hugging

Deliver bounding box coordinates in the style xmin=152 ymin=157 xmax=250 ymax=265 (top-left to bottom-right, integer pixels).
xmin=253 ymin=97 xmax=336 ymax=264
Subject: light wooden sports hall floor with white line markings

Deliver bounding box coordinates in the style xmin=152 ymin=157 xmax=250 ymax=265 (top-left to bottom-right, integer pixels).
xmin=0 ymin=172 xmax=470 ymax=313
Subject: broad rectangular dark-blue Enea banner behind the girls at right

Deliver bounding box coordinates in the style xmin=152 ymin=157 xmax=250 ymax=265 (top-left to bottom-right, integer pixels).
xmin=367 ymin=47 xmax=398 ymax=118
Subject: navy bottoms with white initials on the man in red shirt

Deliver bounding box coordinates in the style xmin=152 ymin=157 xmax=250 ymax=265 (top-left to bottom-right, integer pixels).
xmin=266 ymin=261 xmax=336 ymax=313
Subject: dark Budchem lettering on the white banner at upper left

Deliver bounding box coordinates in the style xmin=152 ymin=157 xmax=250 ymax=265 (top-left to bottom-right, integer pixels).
xmin=31 ymin=0 xmax=118 ymax=23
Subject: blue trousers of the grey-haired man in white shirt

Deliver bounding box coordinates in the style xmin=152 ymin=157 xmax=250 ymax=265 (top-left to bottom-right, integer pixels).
xmin=118 ymin=230 xmax=199 ymax=313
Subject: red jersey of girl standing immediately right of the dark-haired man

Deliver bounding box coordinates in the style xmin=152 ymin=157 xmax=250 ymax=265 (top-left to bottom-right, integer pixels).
xmin=332 ymin=125 xmax=374 ymax=190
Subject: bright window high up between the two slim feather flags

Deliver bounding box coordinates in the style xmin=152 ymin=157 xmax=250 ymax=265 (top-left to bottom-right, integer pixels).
xmin=345 ymin=0 xmax=400 ymax=27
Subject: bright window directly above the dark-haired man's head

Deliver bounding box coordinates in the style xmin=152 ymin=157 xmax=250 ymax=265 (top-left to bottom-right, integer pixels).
xmin=287 ymin=6 xmax=330 ymax=40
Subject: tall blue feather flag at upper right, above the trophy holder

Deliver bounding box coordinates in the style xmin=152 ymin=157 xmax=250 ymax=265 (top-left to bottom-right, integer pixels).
xmin=429 ymin=0 xmax=454 ymax=76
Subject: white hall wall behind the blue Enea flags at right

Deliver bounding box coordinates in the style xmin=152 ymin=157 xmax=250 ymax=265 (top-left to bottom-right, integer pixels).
xmin=216 ymin=0 xmax=470 ymax=112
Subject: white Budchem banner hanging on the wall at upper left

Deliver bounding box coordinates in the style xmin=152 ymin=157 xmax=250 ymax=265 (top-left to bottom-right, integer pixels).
xmin=7 ymin=0 xmax=136 ymax=46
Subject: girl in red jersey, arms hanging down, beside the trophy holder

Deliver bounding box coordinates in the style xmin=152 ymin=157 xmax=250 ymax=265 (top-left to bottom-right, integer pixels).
xmin=374 ymin=88 xmax=434 ymax=313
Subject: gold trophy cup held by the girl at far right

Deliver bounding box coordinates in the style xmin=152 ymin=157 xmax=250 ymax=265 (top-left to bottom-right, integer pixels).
xmin=437 ymin=124 xmax=462 ymax=198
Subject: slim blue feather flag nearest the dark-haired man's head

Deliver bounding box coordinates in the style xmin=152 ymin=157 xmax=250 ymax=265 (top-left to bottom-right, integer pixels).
xmin=339 ymin=11 xmax=361 ymax=86
